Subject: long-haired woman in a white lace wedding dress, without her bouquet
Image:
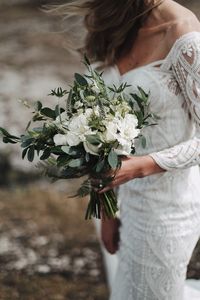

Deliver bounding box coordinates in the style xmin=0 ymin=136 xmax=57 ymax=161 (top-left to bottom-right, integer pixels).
xmin=54 ymin=0 xmax=200 ymax=300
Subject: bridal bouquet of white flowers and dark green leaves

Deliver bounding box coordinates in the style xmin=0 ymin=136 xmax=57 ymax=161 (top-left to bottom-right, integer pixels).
xmin=0 ymin=58 xmax=155 ymax=219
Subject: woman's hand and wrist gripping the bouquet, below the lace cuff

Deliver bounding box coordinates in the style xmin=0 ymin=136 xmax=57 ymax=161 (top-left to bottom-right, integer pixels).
xmin=99 ymin=155 xmax=165 ymax=193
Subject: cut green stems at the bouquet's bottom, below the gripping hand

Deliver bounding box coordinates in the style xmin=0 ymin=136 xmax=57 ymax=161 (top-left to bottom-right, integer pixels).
xmin=85 ymin=190 xmax=118 ymax=220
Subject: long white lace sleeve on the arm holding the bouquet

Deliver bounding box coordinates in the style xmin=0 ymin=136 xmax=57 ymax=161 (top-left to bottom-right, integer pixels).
xmin=150 ymin=33 xmax=200 ymax=171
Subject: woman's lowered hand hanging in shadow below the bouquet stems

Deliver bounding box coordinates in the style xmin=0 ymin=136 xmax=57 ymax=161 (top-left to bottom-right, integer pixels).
xmin=101 ymin=218 xmax=120 ymax=254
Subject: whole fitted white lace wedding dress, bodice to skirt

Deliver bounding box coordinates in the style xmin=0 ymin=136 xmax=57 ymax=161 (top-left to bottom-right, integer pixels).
xmin=97 ymin=32 xmax=200 ymax=300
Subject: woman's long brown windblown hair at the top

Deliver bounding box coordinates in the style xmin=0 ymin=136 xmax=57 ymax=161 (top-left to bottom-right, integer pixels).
xmin=48 ymin=0 xmax=163 ymax=65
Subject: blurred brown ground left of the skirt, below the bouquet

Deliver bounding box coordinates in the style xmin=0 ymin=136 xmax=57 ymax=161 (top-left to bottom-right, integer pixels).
xmin=0 ymin=185 xmax=108 ymax=300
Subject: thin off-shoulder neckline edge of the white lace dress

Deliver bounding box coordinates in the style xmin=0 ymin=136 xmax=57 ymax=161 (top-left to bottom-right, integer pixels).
xmin=113 ymin=31 xmax=200 ymax=78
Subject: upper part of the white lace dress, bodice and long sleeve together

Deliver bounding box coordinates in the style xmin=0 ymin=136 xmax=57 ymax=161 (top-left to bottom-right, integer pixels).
xmin=100 ymin=32 xmax=200 ymax=171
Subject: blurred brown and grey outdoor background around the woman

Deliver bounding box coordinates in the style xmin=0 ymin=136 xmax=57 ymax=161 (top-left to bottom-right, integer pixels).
xmin=0 ymin=0 xmax=200 ymax=300
